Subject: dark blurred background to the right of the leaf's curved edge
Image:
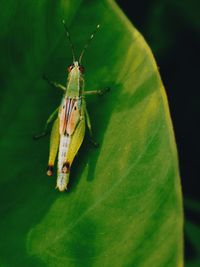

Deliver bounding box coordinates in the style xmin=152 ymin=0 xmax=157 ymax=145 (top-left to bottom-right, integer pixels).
xmin=117 ymin=0 xmax=200 ymax=266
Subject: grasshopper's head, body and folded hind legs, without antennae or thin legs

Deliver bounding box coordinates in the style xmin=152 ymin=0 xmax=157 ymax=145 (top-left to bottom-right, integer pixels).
xmin=47 ymin=61 xmax=86 ymax=191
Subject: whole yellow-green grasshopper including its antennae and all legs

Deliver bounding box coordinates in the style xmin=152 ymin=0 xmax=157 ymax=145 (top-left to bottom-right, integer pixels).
xmin=35 ymin=20 xmax=109 ymax=191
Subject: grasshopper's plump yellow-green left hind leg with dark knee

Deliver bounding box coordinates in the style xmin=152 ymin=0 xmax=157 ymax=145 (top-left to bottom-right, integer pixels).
xmin=47 ymin=118 xmax=60 ymax=176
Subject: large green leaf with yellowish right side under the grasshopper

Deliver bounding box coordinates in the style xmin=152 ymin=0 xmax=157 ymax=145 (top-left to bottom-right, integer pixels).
xmin=0 ymin=0 xmax=183 ymax=267
